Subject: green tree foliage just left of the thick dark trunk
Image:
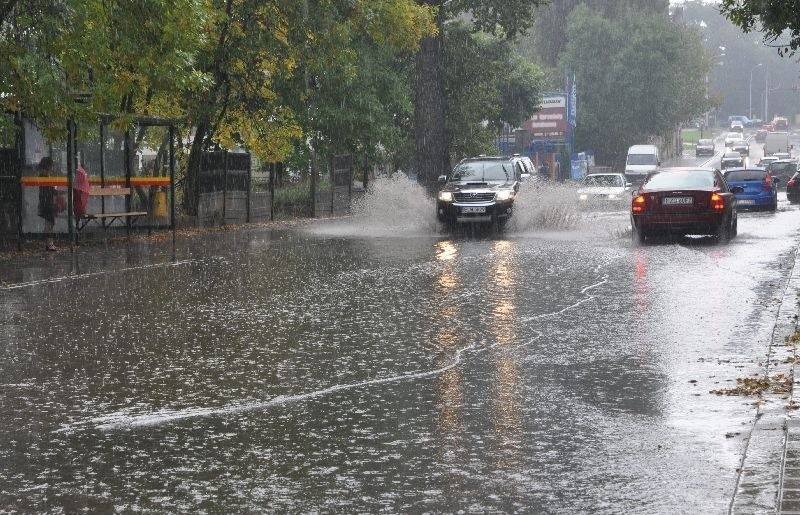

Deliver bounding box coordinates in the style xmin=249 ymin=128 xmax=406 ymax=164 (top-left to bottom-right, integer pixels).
xmin=274 ymin=0 xmax=436 ymax=181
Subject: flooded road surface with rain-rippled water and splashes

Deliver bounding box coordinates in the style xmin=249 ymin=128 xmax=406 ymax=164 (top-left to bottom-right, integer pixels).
xmin=0 ymin=172 xmax=800 ymax=513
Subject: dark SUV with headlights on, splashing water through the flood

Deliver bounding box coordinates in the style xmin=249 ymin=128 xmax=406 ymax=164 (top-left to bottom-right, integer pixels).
xmin=436 ymin=156 xmax=529 ymax=228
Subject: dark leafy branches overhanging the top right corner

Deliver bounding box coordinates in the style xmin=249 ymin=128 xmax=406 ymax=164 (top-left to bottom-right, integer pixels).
xmin=720 ymin=0 xmax=800 ymax=55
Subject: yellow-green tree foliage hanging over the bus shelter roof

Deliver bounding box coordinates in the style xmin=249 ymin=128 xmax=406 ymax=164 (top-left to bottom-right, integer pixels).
xmin=0 ymin=0 xmax=202 ymax=139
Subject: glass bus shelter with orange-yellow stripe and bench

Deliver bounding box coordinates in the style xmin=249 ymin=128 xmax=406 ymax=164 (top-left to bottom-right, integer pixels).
xmin=17 ymin=117 xmax=178 ymax=245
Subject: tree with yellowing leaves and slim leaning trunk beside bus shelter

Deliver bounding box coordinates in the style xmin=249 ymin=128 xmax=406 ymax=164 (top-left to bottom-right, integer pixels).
xmin=186 ymin=0 xmax=435 ymax=212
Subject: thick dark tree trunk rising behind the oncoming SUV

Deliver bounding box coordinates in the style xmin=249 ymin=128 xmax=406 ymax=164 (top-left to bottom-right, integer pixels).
xmin=414 ymin=28 xmax=450 ymax=192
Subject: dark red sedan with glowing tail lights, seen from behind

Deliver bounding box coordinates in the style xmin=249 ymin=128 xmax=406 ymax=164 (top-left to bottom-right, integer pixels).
xmin=631 ymin=168 xmax=741 ymax=243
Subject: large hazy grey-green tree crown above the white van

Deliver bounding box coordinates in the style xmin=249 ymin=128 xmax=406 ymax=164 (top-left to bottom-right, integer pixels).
xmin=562 ymin=6 xmax=711 ymax=163
